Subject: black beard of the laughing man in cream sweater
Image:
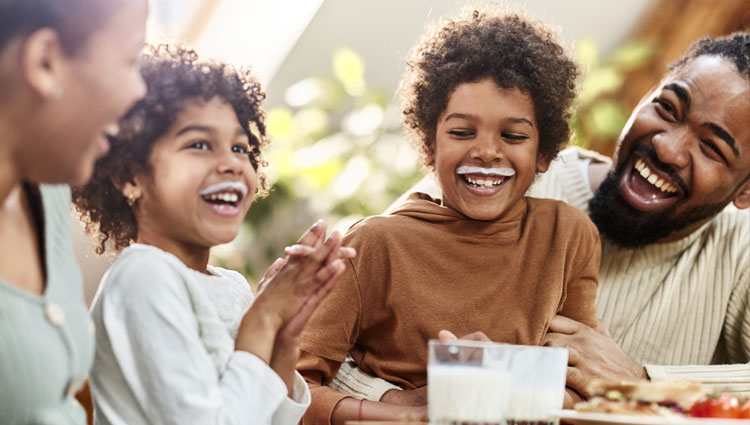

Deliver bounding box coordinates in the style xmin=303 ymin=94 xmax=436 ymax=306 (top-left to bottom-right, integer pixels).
xmin=589 ymin=149 xmax=734 ymax=248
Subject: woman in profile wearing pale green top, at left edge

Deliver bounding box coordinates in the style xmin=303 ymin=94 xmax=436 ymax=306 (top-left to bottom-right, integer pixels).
xmin=0 ymin=0 xmax=148 ymax=425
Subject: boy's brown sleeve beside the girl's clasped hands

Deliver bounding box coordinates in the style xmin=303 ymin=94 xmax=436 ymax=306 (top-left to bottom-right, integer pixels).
xmin=297 ymin=252 xmax=362 ymax=424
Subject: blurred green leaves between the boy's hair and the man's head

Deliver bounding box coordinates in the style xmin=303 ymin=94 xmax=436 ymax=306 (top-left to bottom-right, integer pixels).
xmin=570 ymin=38 xmax=654 ymax=151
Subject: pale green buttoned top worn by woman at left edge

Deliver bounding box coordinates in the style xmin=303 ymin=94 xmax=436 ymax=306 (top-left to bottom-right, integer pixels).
xmin=0 ymin=185 xmax=94 ymax=425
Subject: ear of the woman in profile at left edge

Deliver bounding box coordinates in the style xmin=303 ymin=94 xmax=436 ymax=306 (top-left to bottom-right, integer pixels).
xmin=21 ymin=28 xmax=68 ymax=99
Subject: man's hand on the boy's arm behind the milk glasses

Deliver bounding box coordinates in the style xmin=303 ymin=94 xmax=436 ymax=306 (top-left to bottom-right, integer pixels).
xmin=542 ymin=316 xmax=648 ymax=396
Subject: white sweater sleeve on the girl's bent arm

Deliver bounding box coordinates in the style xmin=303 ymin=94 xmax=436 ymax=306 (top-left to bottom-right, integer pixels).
xmin=103 ymin=258 xmax=294 ymax=425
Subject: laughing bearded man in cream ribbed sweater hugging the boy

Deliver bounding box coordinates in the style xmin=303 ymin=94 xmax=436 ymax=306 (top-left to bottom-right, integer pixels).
xmin=337 ymin=33 xmax=750 ymax=403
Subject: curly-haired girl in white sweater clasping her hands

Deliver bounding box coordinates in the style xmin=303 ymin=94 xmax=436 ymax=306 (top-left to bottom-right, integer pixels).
xmin=74 ymin=46 xmax=353 ymax=425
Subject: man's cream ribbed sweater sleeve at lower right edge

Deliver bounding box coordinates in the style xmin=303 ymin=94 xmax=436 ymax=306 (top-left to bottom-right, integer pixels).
xmin=646 ymin=269 xmax=750 ymax=397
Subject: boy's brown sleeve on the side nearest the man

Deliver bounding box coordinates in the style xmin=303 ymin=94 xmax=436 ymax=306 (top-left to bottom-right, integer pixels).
xmin=560 ymin=213 xmax=602 ymax=328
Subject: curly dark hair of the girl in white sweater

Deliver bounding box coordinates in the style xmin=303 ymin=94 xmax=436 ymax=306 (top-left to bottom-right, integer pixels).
xmin=73 ymin=44 xmax=268 ymax=254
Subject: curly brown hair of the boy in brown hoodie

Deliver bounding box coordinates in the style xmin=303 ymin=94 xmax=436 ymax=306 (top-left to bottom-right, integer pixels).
xmin=399 ymin=5 xmax=578 ymax=169
